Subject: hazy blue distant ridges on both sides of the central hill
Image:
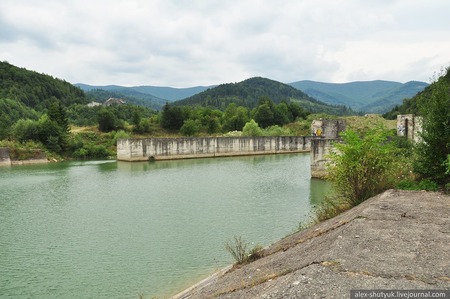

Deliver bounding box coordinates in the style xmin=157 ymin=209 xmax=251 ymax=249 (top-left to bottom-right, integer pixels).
xmin=75 ymin=80 xmax=428 ymax=113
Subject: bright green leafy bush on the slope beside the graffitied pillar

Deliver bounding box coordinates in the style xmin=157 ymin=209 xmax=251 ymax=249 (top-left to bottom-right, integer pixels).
xmin=313 ymin=126 xmax=411 ymax=222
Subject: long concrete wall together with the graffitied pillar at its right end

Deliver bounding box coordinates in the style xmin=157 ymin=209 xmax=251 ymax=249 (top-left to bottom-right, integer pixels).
xmin=117 ymin=119 xmax=346 ymax=178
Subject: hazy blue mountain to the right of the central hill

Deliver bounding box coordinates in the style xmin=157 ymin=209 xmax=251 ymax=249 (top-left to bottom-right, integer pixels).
xmin=289 ymin=80 xmax=428 ymax=113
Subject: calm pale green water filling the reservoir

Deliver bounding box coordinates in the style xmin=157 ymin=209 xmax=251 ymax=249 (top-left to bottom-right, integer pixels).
xmin=0 ymin=154 xmax=328 ymax=298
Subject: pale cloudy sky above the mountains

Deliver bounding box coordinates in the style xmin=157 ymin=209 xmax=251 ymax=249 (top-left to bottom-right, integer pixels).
xmin=0 ymin=0 xmax=450 ymax=87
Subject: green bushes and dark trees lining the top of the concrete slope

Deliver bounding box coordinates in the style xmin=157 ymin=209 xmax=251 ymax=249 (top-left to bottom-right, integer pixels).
xmin=308 ymin=69 xmax=450 ymax=229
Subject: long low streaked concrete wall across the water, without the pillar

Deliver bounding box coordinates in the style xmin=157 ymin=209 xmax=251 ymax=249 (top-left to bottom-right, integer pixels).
xmin=117 ymin=136 xmax=311 ymax=161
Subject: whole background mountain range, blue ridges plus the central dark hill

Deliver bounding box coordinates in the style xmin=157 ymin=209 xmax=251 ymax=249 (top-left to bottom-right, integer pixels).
xmin=75 ymin=78 xmax=428 ymax=114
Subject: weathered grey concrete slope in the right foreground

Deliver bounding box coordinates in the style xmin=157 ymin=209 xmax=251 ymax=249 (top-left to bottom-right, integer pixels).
xmin=174 ymin=190 xmax=450 ymax=298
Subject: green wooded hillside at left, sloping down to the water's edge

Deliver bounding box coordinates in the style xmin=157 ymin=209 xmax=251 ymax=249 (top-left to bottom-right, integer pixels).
xmin=0 ymin=62 xmax=155 ymax=159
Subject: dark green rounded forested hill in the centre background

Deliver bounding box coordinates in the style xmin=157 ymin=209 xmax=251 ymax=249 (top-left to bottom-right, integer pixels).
xmin=174 ymin=77 xmax=353 ymax=115
